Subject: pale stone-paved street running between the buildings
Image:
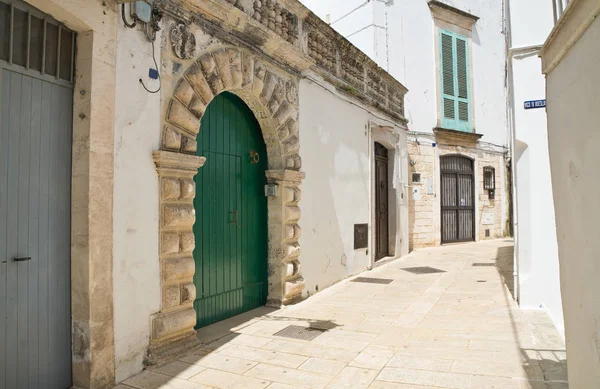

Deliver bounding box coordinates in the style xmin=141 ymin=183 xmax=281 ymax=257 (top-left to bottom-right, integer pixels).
xmin=117 ymin=240 xmax=568 ymax=389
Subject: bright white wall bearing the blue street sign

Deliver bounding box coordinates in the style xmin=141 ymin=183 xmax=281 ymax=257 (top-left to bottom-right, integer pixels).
xmin=508 ymin=0 xmax=564 ymax=336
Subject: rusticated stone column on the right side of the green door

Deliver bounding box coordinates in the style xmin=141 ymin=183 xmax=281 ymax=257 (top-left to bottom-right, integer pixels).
xmin=267 ymin=170 xmax=305 ymax=306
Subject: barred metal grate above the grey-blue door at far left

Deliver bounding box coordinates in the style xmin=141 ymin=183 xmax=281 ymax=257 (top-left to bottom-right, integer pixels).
xmin=0 ymin=0 xmax=76 ymax=83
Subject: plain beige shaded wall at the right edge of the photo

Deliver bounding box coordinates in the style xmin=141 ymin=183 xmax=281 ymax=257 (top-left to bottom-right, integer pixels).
xmin=546 ymin=19 xmax=600 ymax=388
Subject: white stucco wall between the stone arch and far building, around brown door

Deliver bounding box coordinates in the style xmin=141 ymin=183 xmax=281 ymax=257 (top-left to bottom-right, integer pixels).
xmin=300 ymin=79 xmax=408 ymax=294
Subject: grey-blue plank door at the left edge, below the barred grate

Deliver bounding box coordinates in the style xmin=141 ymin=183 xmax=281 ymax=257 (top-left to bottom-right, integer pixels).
xmin=0 ymin=66 xmax=73 ymax=389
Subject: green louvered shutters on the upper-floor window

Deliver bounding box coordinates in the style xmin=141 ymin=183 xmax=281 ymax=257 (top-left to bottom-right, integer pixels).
xmin=440 ymin=31 xmax=471 ymax=132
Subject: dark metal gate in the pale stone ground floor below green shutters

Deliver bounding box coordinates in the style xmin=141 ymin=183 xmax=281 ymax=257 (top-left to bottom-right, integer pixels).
xmin=440 ymin=155 xmax=475 ymax=243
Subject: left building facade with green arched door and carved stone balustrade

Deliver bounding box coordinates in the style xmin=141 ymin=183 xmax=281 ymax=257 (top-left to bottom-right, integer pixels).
xmin=0 ymin=0 xmax=409 ymax=389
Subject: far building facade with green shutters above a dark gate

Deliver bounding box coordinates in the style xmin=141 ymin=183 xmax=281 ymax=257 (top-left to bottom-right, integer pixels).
xmin=304 ymin=0 xmax=511 ymax=249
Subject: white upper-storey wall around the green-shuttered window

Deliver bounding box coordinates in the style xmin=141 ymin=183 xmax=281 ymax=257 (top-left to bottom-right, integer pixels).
xmin=302 ymin=0 xmax=509 ymax=146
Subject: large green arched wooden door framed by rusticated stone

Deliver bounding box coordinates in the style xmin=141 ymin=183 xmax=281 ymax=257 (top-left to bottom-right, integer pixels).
xmin=194 ymin=93 xmax=267 ymax=328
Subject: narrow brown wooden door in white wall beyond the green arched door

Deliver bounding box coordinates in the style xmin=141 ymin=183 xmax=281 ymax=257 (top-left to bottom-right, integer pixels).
xmin=375 ymin=143 xmax=389 ymax=260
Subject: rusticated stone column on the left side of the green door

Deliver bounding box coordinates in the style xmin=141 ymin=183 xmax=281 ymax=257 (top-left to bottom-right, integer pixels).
xmin=152 ymin=151 xmax=206 ymax=344
